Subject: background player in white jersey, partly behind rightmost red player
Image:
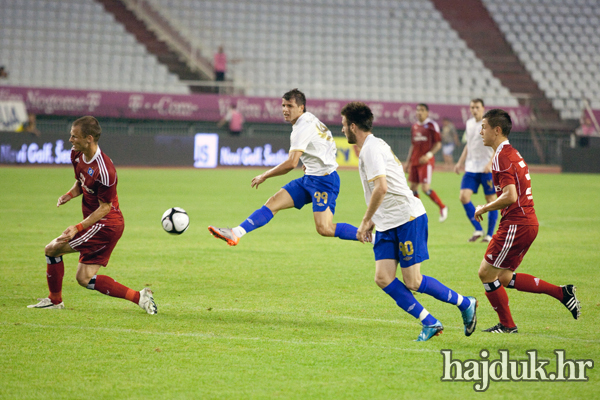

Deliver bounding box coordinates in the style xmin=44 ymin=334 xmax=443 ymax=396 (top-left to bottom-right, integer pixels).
xmin=454 ymin=99 xmax=498 ymax=242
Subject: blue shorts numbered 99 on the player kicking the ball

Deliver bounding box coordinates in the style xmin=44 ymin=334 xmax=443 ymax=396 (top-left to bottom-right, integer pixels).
xmin=283 ymin=171 xmax=340 ymax=214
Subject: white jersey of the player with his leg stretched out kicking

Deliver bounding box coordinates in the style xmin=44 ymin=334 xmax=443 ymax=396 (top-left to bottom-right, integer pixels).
xmin=290 ymin=112 xmax=338 ymax=176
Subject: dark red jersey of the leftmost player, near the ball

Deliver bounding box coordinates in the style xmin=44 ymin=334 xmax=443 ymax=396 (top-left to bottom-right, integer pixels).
xmin=71 ymin=147 xmax=123 ymax=221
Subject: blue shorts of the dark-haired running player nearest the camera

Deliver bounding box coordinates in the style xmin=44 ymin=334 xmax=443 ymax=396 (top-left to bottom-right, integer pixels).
xmin=373 ymin=214 xmax=429 ymax=268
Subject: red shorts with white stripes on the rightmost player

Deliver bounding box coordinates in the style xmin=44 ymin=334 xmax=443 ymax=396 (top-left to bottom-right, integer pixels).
xmin=484 ymin=222 xmax=538 ymax=271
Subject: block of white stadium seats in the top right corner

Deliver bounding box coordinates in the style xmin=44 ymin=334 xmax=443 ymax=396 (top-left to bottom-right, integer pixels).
xmin=483 ymin=0 xmax=600 ymax=119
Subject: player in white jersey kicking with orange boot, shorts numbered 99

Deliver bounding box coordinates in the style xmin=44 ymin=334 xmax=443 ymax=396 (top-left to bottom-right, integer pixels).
xmin=208 ymin=89 xmax=357 ymax=246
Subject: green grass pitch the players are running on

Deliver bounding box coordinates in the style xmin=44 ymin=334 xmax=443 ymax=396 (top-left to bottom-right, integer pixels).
xmin=0 ymin=167 xmax=600 ymax=399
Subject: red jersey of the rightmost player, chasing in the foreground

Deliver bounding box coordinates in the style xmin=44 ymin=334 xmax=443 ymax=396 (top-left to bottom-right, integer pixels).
xmin=492 ymin=140 xmax=539 ymax=225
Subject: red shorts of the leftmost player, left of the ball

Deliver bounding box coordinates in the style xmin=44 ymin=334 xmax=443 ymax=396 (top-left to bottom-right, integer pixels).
xmin=69 ymin=221 xmax=125 ymax=267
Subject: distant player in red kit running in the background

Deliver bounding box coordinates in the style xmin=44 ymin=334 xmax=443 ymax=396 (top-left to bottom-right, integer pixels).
xmin=406 ymin=103 xmax=448 ymax=222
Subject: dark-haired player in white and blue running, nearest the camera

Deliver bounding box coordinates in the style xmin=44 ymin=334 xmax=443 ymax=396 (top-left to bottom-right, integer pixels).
xmin=342 ymin=102 xmax=477 ymax=342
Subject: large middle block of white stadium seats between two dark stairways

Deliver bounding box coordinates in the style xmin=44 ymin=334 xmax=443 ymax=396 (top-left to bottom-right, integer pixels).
xmin=158 ymin=0 xmax=518 ymax=105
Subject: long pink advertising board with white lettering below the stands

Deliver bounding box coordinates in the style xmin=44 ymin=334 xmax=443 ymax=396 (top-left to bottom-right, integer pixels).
xmin=0 ymin=86 xmax=529 ymax=131
